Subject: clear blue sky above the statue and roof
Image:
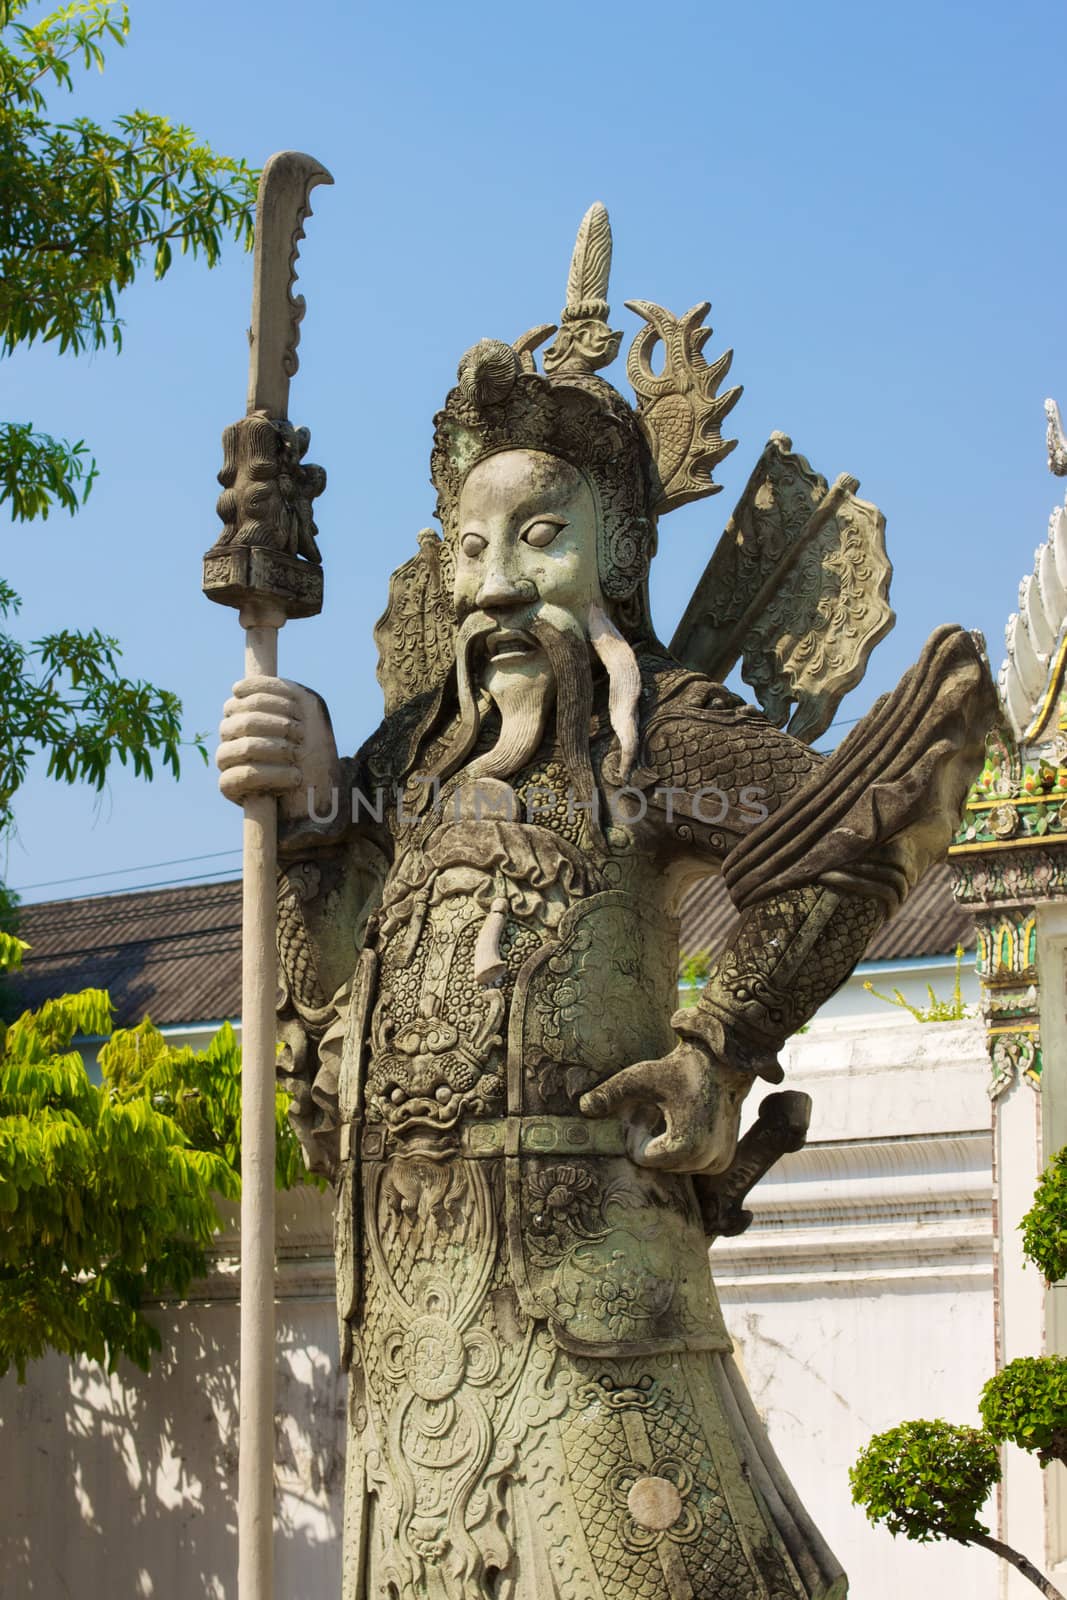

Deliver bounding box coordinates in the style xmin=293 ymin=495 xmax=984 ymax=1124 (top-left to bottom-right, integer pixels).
xmin=0 ymin=0 xmax=1067 ymax=899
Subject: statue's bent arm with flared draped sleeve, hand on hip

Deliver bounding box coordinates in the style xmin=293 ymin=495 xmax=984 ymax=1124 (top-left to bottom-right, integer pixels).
xmin=584 ymin=627 xmax=995 ymax=1171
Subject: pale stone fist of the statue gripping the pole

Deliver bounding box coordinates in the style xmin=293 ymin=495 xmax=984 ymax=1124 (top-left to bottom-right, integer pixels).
xmin=214 ymin=678 xmax=341 ymax=821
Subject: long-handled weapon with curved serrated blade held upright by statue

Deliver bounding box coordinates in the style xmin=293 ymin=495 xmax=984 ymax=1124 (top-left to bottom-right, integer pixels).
xmin=203 ymin=150 xmax=333 ymax=1600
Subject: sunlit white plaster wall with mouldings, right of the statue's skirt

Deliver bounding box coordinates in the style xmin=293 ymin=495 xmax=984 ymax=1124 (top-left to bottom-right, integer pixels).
xmin=712 ymin=1013 xmax=1000 ymax=1600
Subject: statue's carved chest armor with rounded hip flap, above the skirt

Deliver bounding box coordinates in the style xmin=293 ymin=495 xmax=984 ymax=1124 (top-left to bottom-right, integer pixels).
xmin=362 ymin=763 xmax=723 ymax=1355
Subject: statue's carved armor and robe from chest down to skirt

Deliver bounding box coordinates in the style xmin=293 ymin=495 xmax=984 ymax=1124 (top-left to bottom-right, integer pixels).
xmin=302 ymin=707 xmax=844 ymax=1600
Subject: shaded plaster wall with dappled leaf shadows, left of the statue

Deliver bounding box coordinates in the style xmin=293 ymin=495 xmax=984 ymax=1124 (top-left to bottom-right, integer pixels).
xmin=0 ymin=1190 xmax=346 ymax=1600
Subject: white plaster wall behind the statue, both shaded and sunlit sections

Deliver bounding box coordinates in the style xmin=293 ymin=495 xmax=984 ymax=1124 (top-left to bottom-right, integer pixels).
xmin=0 ymin=1010 xmax=998 ymax=1600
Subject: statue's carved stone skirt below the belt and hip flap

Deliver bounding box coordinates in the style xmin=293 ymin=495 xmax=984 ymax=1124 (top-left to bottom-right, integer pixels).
xmin=342 ymin=1157 xmax=846 ymax=1600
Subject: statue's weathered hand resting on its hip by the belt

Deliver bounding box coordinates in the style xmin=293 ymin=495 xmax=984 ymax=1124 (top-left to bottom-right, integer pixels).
xmin=579 ymin=1038 xmax=752 ymax=1173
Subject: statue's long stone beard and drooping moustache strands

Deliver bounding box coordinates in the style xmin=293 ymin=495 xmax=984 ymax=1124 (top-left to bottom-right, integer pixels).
xmin=432 ymin=602 xmax=640 ymax=805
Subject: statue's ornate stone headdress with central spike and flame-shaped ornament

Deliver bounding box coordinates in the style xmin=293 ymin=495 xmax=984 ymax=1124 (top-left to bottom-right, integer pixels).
xmin=430 ymin=202 xmax=741 ymax=611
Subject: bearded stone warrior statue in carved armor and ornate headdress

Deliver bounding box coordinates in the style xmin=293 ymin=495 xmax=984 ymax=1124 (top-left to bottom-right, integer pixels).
xmin=219 ymin=206 xmax=993 ymax=1600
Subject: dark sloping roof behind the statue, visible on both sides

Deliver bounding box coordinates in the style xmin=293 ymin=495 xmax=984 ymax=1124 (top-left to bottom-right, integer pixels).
xmin=13 ymin=864 xmax=974 ymax=1027
